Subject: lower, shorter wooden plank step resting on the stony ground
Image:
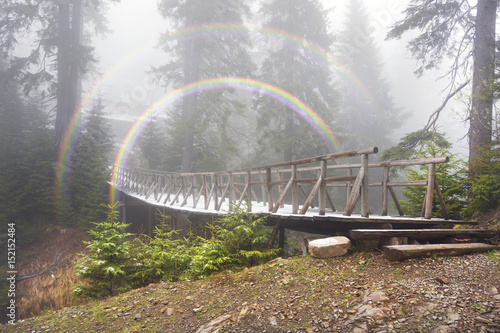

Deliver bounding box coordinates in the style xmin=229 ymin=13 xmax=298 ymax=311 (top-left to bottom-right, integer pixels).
xmin=382 ymin=243 xmax=498 ymax=260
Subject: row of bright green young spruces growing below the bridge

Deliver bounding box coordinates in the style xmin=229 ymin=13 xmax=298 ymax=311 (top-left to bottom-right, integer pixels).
xmin=73 ymin=205 xmax=279 ymax=299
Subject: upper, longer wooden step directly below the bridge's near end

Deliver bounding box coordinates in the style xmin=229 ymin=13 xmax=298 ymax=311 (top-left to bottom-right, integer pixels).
xmin=349 ymin=229 xmax=498 ymax=240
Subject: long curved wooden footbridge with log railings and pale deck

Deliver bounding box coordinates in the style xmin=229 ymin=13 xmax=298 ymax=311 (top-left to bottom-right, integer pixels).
xmin=113 ymin=147 xmax=474 ymax=234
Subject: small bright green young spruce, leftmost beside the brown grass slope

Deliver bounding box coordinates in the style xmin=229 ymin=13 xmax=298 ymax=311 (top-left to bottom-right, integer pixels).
xmin=73 ymin=204 xmax=135 ymax=298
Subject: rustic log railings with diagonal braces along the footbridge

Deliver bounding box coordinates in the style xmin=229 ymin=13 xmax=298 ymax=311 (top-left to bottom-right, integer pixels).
xmin=114 ymin=147 xmax=448 ymax=219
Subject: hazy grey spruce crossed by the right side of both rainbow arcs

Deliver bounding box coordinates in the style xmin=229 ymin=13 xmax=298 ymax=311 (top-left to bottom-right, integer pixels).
xmin=256 ymin=0 xmax=336 ymax=161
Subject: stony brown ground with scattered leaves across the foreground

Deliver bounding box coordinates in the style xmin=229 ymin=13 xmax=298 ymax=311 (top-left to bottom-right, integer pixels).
xmin=0 ymin=214 xmax=500 ymax=333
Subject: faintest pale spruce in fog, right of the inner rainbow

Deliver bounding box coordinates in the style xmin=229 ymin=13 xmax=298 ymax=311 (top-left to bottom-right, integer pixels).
xmin=339 ymin=0 xmax=401 ymax=150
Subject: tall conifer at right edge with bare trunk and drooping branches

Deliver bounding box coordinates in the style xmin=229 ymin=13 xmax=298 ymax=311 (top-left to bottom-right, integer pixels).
xmin=388 ymin=0 xmax=498 ymax=175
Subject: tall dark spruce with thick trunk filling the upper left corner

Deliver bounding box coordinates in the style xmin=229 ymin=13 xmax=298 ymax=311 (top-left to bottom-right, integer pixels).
xmin=0 ymin=0 xmax=119 ymax=145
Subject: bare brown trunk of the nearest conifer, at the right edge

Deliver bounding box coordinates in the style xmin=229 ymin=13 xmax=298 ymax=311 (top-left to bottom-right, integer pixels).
xmin=469 ymin=0 xmax=497 ymax=176
